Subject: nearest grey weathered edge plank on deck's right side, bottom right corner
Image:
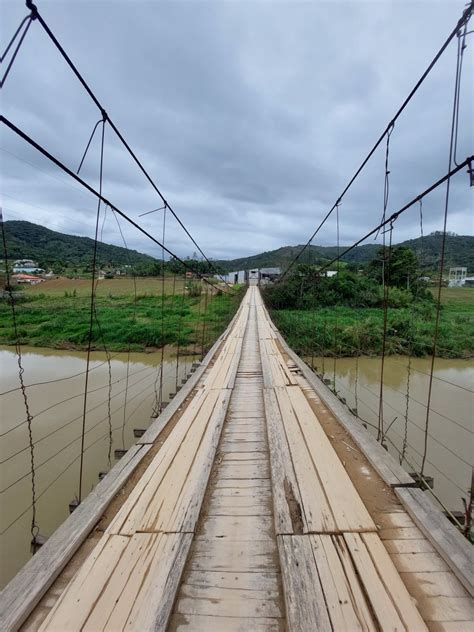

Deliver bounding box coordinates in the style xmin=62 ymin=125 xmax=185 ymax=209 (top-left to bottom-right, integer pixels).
xmin=395 ymin=488 xmax=474 ymax=597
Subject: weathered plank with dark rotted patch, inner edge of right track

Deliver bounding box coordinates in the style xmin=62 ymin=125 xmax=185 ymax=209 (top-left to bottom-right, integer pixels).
xmin=263 ymin=389 xmax=308 ymax=535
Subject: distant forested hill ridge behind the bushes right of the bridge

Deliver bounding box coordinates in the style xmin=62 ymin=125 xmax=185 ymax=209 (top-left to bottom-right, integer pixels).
xmin=216 ymin=233 xmax=474 ymax=272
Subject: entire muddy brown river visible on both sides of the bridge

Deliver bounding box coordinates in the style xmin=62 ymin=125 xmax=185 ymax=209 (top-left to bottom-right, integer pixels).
xmin=0 ymin=347 xmax=474 ymax=585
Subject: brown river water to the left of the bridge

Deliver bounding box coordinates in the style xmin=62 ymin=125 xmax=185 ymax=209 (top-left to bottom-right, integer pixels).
xmin=0 ymin=347 xmax=189 ymax=587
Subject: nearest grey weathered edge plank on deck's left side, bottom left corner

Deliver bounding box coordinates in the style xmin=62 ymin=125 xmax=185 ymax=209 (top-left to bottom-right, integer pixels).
xmin=0 ymin=446 xmax=150 ymax=630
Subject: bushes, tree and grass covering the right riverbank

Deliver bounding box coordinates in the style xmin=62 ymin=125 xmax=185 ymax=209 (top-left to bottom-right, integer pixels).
xmin=264 ymin=249 xmax=474 ymax=358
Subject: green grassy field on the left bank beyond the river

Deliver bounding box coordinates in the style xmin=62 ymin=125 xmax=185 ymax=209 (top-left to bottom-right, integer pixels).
xmin=0 ymin=277 xmax=241 ymax=354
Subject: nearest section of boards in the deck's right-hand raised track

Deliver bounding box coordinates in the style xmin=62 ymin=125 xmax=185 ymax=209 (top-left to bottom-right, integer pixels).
xmin=278 ymin=533 xmax=427 ymax=632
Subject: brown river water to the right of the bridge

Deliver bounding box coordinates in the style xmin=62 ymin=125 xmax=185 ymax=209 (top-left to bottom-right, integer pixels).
xmin=306 ymin=356 xmax=474 ymax=511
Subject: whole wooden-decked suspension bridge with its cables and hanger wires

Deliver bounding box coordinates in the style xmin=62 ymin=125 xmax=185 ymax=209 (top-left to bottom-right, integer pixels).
xmin=0 ymin=0 xmax=474 ymax=632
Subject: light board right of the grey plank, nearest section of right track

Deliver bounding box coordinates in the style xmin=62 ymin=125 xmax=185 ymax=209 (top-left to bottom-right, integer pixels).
xmin=309 ymin=535 xmax=377 ymax=632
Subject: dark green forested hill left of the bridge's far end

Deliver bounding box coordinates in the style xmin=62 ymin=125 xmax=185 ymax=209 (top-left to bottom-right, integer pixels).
xmin=4 ymin=220 xmax=155 ymax=269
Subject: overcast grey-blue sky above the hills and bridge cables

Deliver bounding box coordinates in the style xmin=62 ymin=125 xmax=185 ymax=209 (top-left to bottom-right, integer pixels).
xmin=0 ymin=0 xmax=474 ymax=258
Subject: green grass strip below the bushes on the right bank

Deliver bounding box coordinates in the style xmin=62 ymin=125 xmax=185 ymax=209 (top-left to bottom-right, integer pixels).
xmin=272 ymin=288 xmax=474 ymax=358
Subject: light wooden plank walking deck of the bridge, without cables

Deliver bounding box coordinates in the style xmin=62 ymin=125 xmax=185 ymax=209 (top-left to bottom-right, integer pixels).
xmin=27 ymin=287 xmax=474 ymax=632
